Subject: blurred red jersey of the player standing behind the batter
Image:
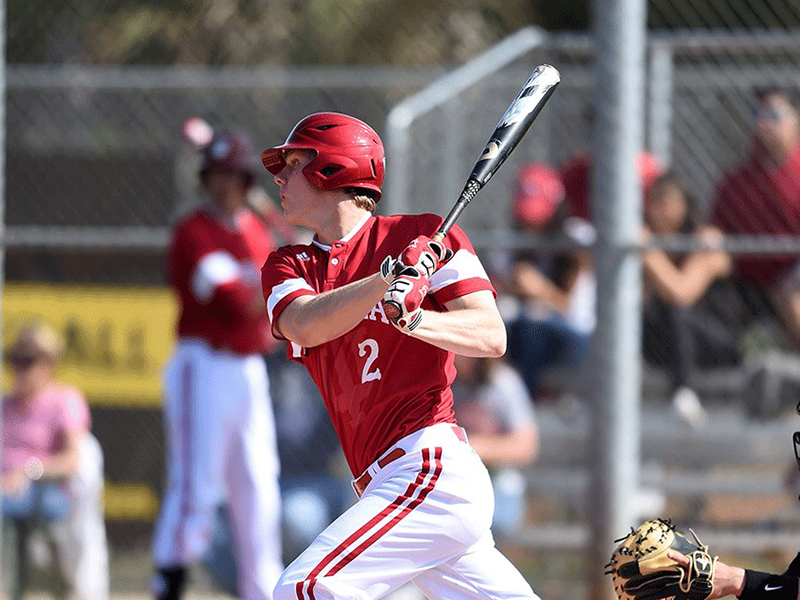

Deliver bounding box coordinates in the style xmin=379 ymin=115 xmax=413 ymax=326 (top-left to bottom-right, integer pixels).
xmin=167 ymin=208 xmax=275 ymax=354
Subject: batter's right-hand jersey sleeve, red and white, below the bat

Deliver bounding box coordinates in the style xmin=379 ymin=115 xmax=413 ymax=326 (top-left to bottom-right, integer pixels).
xmin=430 ymin=225 xmax=497 ymax=304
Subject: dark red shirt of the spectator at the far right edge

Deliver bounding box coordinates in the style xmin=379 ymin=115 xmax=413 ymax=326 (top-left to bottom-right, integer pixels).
xmin=710 ymin=145 xmax=800 ymax=284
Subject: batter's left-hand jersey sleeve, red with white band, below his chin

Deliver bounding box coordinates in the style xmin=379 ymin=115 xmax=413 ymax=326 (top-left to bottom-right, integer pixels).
xmin=261 ymin=248 xmax=317 ymax=340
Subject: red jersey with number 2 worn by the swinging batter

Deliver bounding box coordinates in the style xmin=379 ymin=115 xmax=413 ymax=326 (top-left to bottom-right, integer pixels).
xmin=262 ymin=214 xmax=494 ymax=475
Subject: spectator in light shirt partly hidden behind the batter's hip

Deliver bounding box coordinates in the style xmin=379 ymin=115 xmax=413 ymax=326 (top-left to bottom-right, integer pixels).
xmin=453 ymin=355 xmax=539 ymax=535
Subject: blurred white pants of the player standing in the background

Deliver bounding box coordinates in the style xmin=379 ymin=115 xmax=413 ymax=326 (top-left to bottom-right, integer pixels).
xmin=153 ymin=340 xmax=283 ymax=600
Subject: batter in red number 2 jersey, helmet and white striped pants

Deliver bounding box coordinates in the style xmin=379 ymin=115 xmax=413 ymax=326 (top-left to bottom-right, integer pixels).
xmin=262 ymin=113 xmax=537 ymax=600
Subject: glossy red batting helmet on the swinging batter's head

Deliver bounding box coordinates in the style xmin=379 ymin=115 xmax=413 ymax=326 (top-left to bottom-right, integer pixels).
xmin=261 ymin=113 xmax=384 ymax=201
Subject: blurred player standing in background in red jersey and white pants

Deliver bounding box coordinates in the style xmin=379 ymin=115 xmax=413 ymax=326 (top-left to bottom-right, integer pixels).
xmin=153 ymin=133 xmax=282 ymax=600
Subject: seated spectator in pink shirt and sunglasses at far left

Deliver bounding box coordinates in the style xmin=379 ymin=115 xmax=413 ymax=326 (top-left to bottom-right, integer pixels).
xmin=2 ymin=323 xmax=100 ymax=598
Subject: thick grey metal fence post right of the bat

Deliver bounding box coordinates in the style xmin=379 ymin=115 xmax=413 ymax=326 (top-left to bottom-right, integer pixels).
xmin=587 ymin=0 xmax=645 ymax=600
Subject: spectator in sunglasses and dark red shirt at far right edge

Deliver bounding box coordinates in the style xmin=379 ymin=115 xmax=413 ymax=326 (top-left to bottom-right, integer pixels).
xmin=710 ymin=87 xmax=800 ymax=349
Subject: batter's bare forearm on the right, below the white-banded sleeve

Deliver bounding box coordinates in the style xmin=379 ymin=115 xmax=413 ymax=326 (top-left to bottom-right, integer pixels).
xmin=411 ymin=308 xmax=506 ymax=357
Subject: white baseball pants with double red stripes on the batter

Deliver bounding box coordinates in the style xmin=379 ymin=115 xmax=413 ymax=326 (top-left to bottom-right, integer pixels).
xmin=275 ymin=424 xmax=538 ymax=600
